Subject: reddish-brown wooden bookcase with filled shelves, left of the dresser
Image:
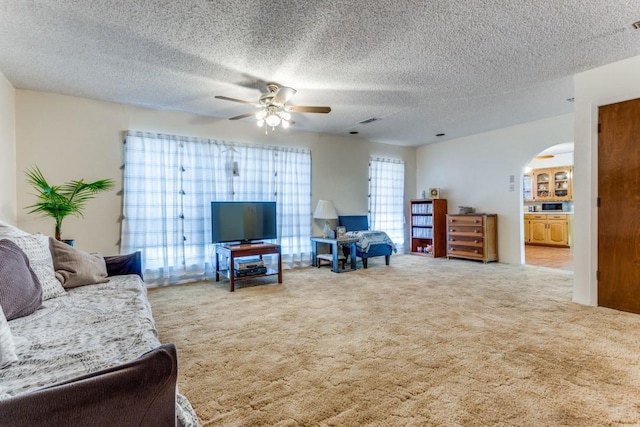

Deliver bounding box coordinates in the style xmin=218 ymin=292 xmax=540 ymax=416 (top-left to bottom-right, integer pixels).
xmin=411 ymin=199 xmax=447 ymax=258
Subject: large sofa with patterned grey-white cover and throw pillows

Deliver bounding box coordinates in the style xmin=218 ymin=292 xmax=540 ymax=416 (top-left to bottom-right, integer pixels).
xmin=0 ymin=221 xmax=199 ymax=427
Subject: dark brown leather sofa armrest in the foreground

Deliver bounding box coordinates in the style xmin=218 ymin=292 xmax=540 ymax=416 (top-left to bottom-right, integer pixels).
xmin=0 ymin=344 xmax=178 ymax=426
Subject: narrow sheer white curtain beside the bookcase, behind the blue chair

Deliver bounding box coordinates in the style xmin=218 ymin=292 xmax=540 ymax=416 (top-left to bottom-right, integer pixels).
xmin=369 ymin=158 xmax=404 ymax=250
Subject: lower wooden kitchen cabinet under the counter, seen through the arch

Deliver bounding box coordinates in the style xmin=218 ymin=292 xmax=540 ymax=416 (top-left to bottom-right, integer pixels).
xmin=524 ymin=214 xmax=572 ymax=248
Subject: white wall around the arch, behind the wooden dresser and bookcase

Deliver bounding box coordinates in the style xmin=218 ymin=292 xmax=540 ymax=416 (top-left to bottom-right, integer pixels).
xmin=414 ymin=114 xmax=574 ymax=264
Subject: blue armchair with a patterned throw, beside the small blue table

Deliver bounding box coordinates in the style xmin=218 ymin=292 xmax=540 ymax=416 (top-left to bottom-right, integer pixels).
xmin=338 ymin=215 xmax=397 ymax=268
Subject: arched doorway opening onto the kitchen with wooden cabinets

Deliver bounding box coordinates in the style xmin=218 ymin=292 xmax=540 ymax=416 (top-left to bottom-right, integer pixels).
xmin=522 ymin=142 xmax=573 ymax=270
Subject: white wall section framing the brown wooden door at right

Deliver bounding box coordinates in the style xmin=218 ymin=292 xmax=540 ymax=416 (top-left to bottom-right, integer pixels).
xmin=573 ymin=56 xmax=640 ymax=305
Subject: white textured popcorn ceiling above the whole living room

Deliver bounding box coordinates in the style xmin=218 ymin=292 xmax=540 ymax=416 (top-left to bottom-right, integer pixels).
xmin=0 ymin=0 xmax=640 ymax=146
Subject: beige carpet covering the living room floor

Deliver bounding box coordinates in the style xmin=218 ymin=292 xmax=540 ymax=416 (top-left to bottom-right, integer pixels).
xmin=149 ymin=255 xmax=640 ymax=426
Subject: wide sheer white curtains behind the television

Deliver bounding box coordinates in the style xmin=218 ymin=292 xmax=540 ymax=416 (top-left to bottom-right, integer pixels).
xmin=121 ymin=132 xmax=311 ymax=284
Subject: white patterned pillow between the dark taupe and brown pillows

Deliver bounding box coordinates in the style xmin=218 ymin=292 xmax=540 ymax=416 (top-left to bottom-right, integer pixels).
xmin=9 ymin=234 xmax=66 ymax=301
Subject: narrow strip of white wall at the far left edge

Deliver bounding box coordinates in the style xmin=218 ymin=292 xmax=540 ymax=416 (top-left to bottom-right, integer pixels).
xmin=0 ymin=73 xmax=17 ymax=224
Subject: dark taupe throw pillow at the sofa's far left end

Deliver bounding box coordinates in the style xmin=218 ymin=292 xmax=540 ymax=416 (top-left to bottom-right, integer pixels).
xmin=0 ymin=239 xmax=42 ymax=320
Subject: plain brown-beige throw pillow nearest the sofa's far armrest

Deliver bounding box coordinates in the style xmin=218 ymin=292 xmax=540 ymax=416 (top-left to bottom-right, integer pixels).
xmin=49 ymin=237 xmax=109 ymax=289
